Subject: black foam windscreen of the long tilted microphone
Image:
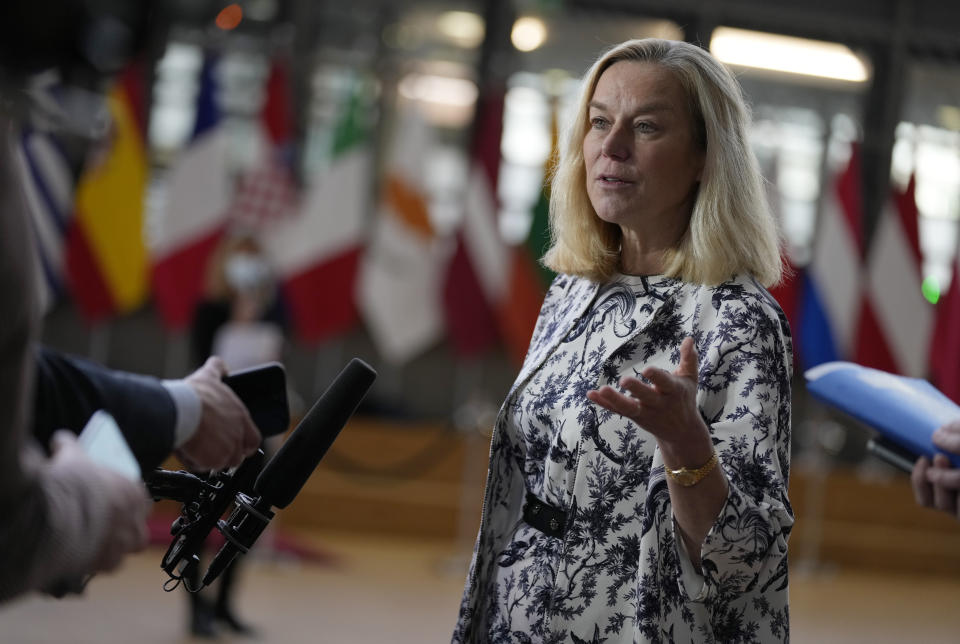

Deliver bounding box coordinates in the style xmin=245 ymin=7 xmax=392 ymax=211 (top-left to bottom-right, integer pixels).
xmin=254 ymin=358 xmax=377 ymax=508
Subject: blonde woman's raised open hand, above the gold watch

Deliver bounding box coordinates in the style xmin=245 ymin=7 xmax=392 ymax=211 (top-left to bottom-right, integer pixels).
xmin=587 ymin=337 xmax=709 ymax=445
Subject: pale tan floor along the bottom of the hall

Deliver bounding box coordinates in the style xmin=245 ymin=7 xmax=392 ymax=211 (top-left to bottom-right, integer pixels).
xmin=0 ymin=533 xmax=960 ymax=644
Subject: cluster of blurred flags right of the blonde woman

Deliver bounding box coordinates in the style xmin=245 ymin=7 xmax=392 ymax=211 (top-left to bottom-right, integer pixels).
xmin=773 ymin=143 xmax=960 ymax=402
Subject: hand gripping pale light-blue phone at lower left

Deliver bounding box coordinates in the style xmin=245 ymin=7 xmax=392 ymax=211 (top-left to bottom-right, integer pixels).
xmin=50 ymin=430 xmax=153 ymax=573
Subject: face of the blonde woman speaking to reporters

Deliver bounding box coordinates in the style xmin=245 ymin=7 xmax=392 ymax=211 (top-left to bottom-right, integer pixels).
xmin=583 ymin=61 xmax=704 ymax=243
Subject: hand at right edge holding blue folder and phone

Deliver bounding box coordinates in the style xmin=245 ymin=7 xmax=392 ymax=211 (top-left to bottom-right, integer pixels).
xmin=910 ymin=420 xmax=960 ymax=520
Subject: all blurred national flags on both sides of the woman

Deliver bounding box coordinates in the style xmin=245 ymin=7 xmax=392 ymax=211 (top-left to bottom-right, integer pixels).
xmin=22 ymin=59 xmax=960 ymax=401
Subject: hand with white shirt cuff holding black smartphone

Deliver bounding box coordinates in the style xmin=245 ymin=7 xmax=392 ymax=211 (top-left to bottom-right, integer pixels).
xmin=177 ymin=356 xmax=260 ymax=471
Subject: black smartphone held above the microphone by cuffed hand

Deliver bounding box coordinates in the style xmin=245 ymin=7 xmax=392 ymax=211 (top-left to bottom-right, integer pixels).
xmin=223 ymin=362 xmax=290 ymax=438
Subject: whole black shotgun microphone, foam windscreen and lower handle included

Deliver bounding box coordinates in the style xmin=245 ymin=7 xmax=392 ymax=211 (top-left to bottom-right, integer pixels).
xmin=203 ymin=358 xmax=377 ymax=586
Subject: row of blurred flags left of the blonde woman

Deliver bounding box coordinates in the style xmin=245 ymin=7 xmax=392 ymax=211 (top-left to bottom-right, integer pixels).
xmin=22 ymin=58 xmax=549 ymax=372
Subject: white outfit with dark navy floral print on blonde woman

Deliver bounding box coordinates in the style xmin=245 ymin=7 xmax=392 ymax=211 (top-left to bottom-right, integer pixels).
xmin=453 ymin=275 xmax=793 ymax=644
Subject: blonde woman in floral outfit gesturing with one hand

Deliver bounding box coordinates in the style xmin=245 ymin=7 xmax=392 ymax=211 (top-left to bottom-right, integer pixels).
xmin=453 ymin=39 xmax=793 ymax=644
